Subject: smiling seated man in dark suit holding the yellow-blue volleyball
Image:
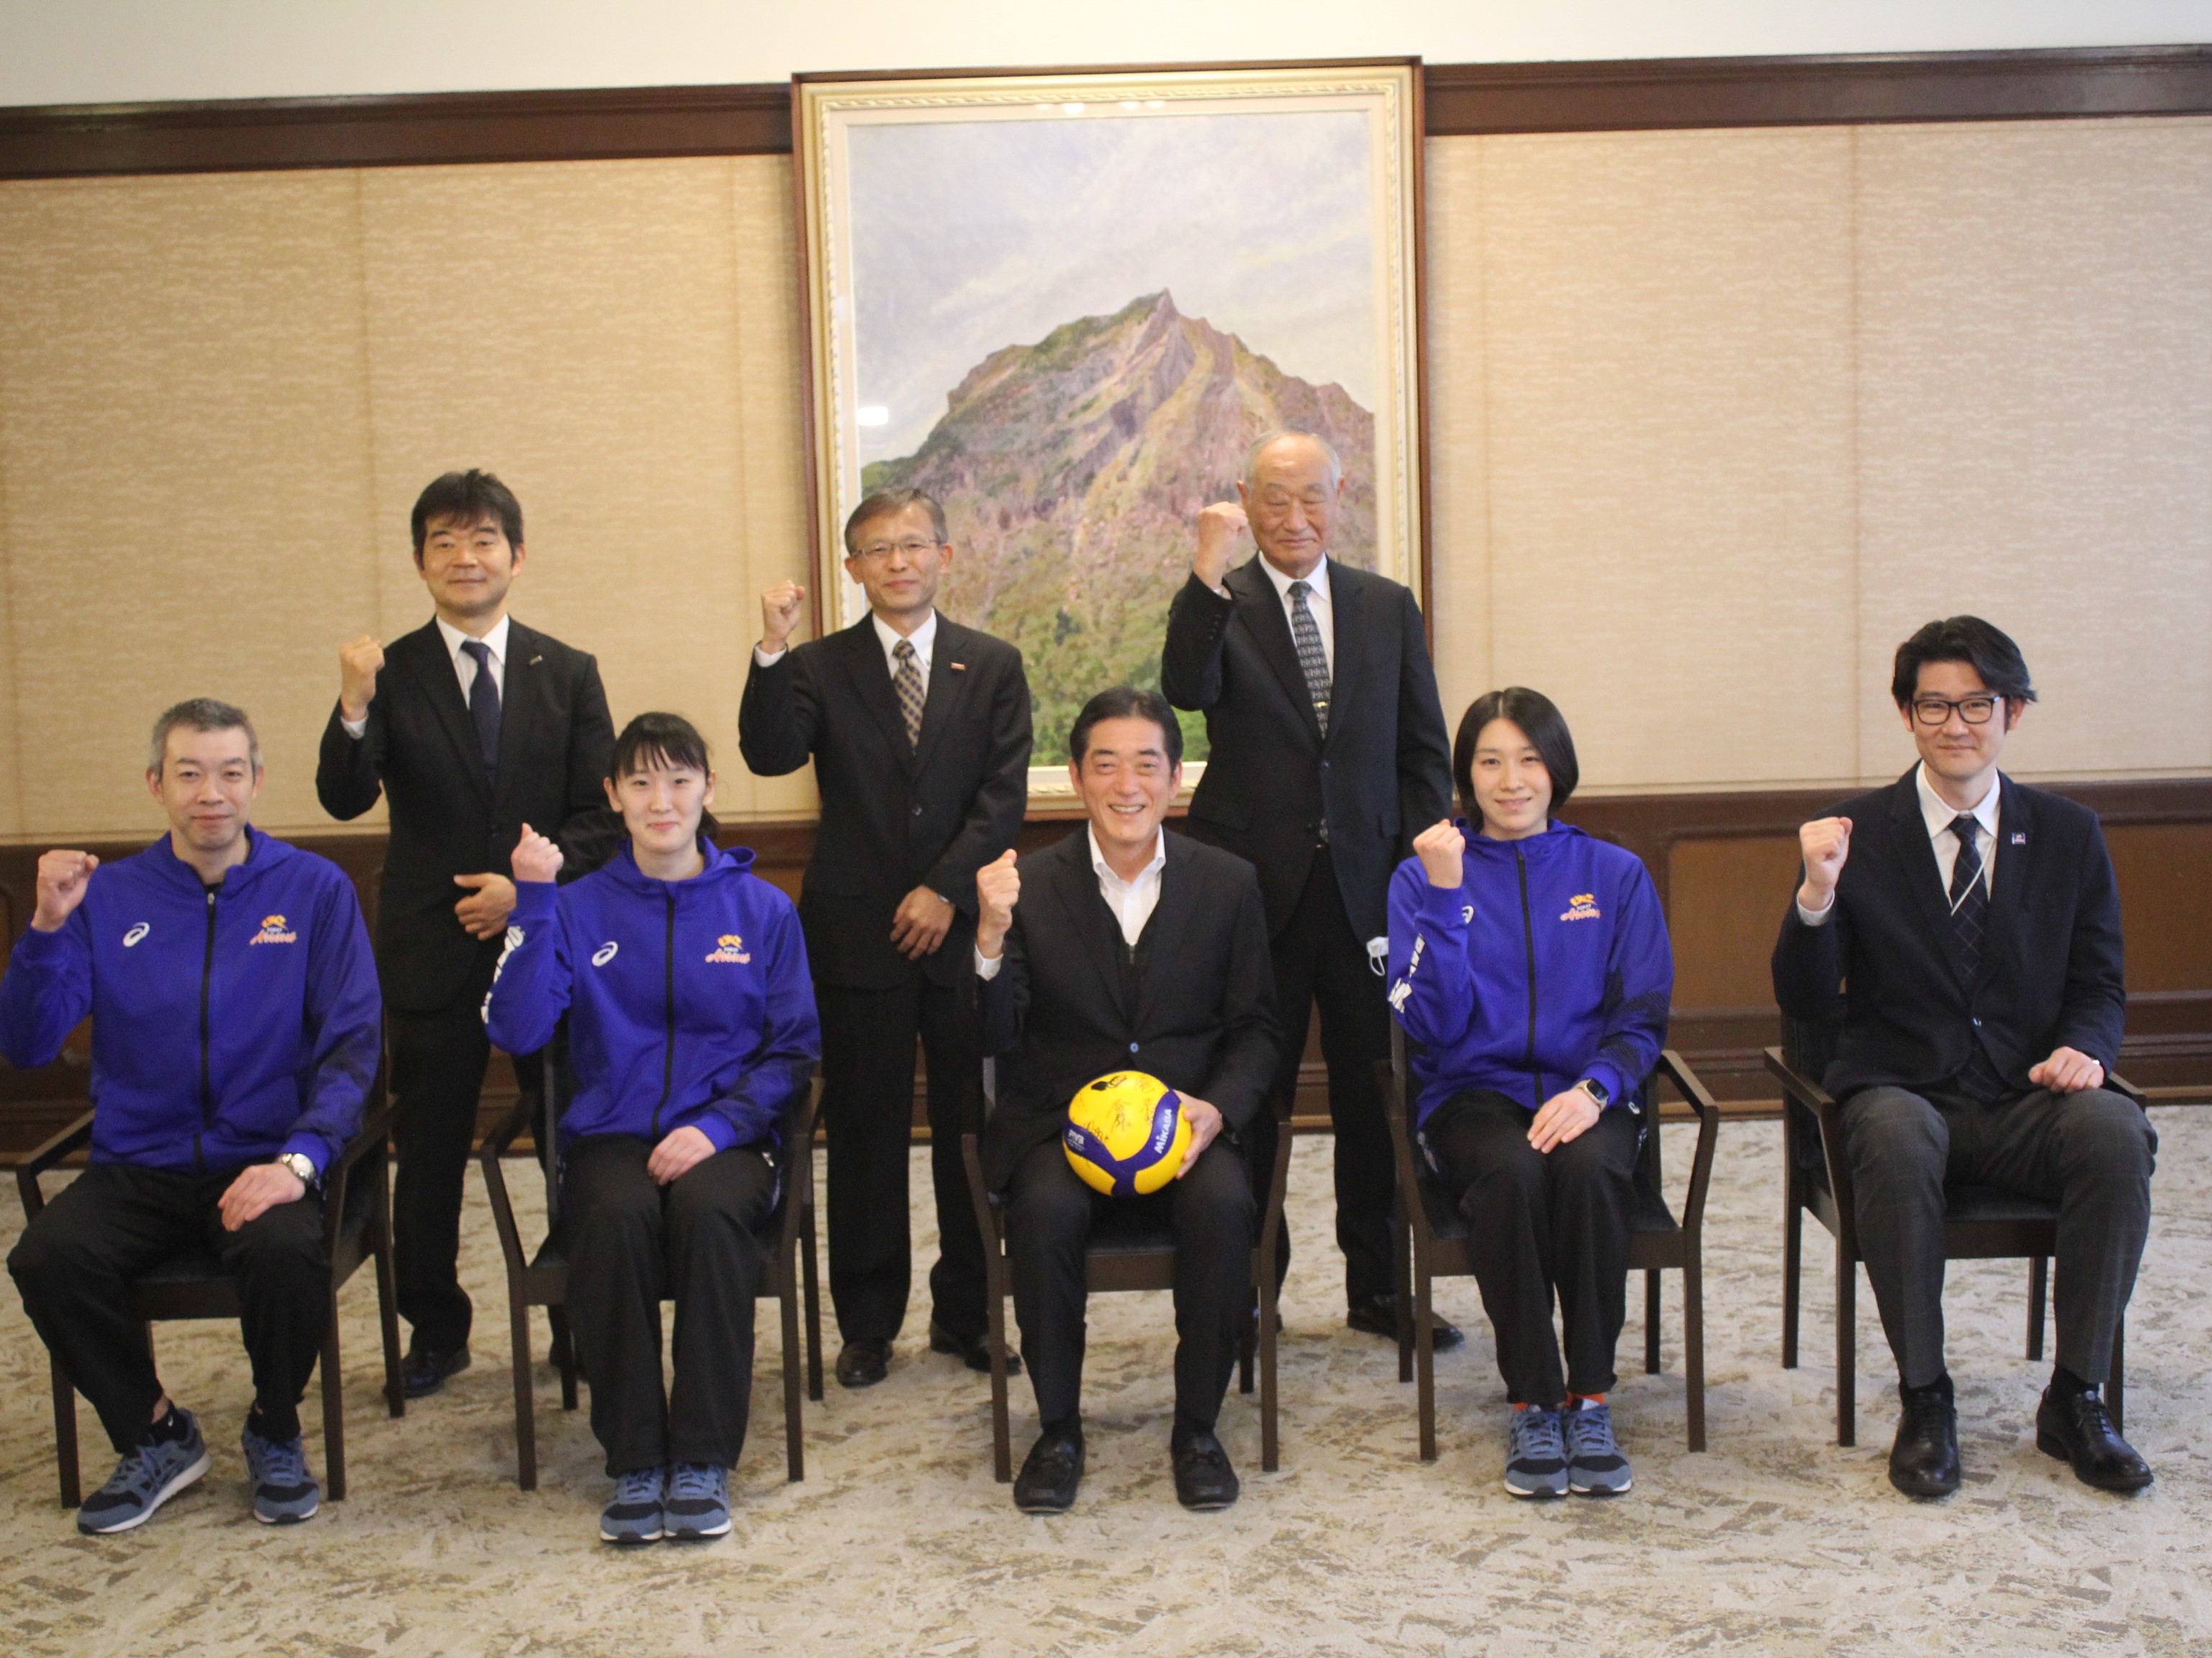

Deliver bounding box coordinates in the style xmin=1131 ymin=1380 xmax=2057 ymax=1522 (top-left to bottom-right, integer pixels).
xmin=975 ymin=685 xmax=1276 ymax=1514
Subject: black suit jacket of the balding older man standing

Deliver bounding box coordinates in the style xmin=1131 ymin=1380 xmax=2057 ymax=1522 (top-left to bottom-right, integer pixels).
xmin=1159 ymin=555 xmax=1451 ymax=940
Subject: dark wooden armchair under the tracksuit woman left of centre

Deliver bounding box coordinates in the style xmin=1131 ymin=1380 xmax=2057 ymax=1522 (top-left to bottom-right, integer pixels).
xmin=476 ymin=1052 xmax=823 ymax=1490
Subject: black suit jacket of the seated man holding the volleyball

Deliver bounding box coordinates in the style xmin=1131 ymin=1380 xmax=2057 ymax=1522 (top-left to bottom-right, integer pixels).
xmin=969 ymin=829 xmax=1276 ymax=1187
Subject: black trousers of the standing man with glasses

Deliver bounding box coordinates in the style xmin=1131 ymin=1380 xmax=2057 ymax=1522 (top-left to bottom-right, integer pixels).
xmin=814 ymin=973 xmax=989 ymax=1342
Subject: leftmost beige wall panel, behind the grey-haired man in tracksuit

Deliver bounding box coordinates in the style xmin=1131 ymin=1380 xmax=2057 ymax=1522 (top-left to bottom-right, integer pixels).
xmin=0 ymin=173 xmax=374 ymax=835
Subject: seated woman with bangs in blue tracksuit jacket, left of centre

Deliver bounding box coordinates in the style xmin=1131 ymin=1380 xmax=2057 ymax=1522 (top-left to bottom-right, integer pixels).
xmin=484 ymin=714 xmax=821 ymax=1543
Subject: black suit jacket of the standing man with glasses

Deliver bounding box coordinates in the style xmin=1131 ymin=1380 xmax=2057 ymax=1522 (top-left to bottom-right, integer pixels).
xmin=736 ymin=612 xmax=1029 ymax=990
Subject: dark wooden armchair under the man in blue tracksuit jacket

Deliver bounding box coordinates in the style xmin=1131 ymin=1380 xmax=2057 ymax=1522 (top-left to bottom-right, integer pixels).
xmin=16 ymin=1068 xmax=407 ymax=1508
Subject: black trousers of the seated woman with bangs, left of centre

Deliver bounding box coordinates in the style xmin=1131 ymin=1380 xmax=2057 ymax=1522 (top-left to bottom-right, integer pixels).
xmin=562 ymin=1134 xmax=777 ymax=1477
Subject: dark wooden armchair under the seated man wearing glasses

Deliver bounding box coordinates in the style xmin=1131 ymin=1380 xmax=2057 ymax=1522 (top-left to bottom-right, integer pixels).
xmin=1765 ymin=1015 xmax=2144 ymax=1446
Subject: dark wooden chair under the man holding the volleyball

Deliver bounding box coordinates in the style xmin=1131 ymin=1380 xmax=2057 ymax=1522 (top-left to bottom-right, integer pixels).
xmin=960 ymin=1059 xmax=1290 ymax=1485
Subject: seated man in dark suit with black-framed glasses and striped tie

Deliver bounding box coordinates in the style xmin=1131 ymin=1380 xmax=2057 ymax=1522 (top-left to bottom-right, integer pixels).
xmin=1774 ymin=617 xmax=2159 ymax=1497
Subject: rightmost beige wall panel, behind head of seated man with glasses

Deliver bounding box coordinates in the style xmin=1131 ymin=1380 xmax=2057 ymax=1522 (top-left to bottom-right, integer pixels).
xmin=1858 ymin=119 xmax=2212 ymax=776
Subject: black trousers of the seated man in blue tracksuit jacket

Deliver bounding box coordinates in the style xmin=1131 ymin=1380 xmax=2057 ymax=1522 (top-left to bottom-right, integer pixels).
xmin=6 ymin=1163 xmax=330 ymax=1454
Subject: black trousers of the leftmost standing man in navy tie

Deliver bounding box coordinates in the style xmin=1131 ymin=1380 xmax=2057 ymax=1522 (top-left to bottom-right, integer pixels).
xmin=387 ymin=955 xmax=540 ymax=1353
